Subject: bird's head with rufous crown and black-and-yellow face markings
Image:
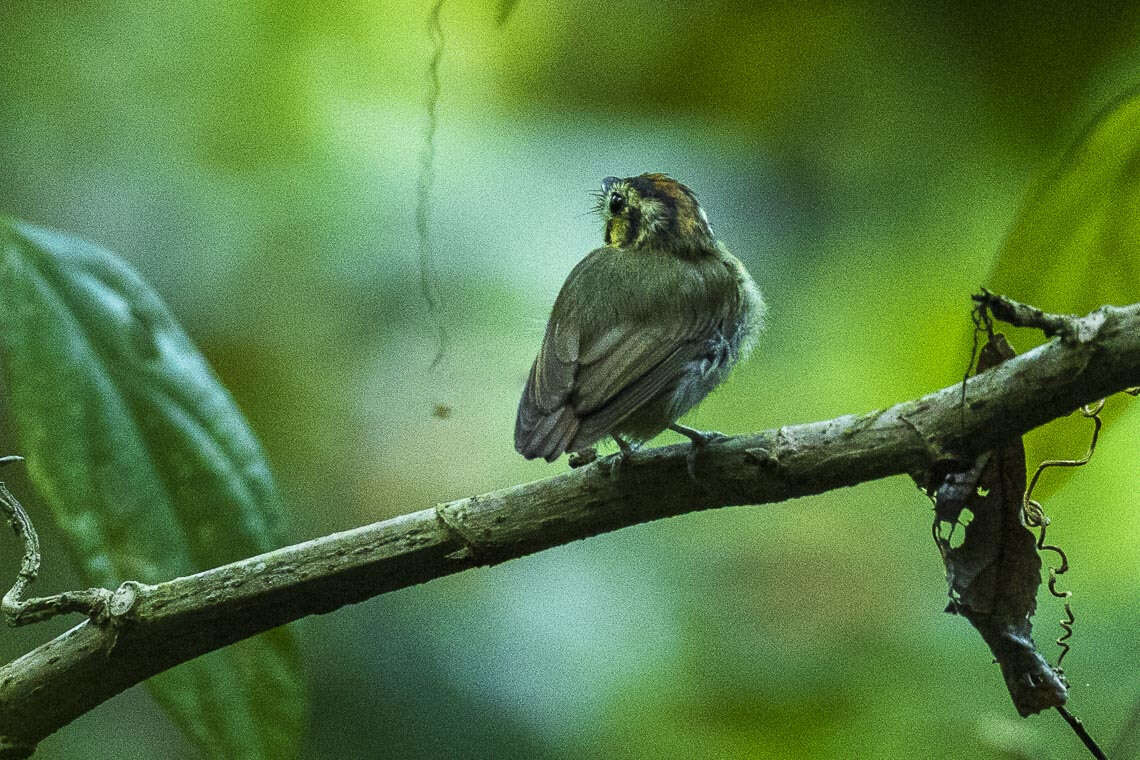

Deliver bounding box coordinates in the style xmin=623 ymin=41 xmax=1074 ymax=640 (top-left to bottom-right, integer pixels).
xmin=597 ymin=173 xmax=716 ymax=255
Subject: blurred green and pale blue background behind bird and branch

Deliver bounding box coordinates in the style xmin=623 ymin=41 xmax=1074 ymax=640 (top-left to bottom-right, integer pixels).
xmin=0 ymin=0 xmax=1140 ymax=759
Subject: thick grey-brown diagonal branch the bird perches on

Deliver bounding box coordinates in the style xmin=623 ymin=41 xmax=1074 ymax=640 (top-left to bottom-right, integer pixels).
xmin=0 ymin=294 xmax=1140 ymax=758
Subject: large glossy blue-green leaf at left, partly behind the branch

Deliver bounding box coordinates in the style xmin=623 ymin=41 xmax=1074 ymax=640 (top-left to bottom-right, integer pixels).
xmin=0 ymin=218 xmax=304 ymax=759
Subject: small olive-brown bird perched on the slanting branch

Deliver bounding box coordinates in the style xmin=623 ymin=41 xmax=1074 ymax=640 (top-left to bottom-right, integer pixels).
xmin=514 ymin=173 xmax=765 ymax=474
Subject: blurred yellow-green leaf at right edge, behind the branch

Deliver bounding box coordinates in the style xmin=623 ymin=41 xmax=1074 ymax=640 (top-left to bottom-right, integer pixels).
xmin=985 ymin=89 xmax=1140 ymax=497
